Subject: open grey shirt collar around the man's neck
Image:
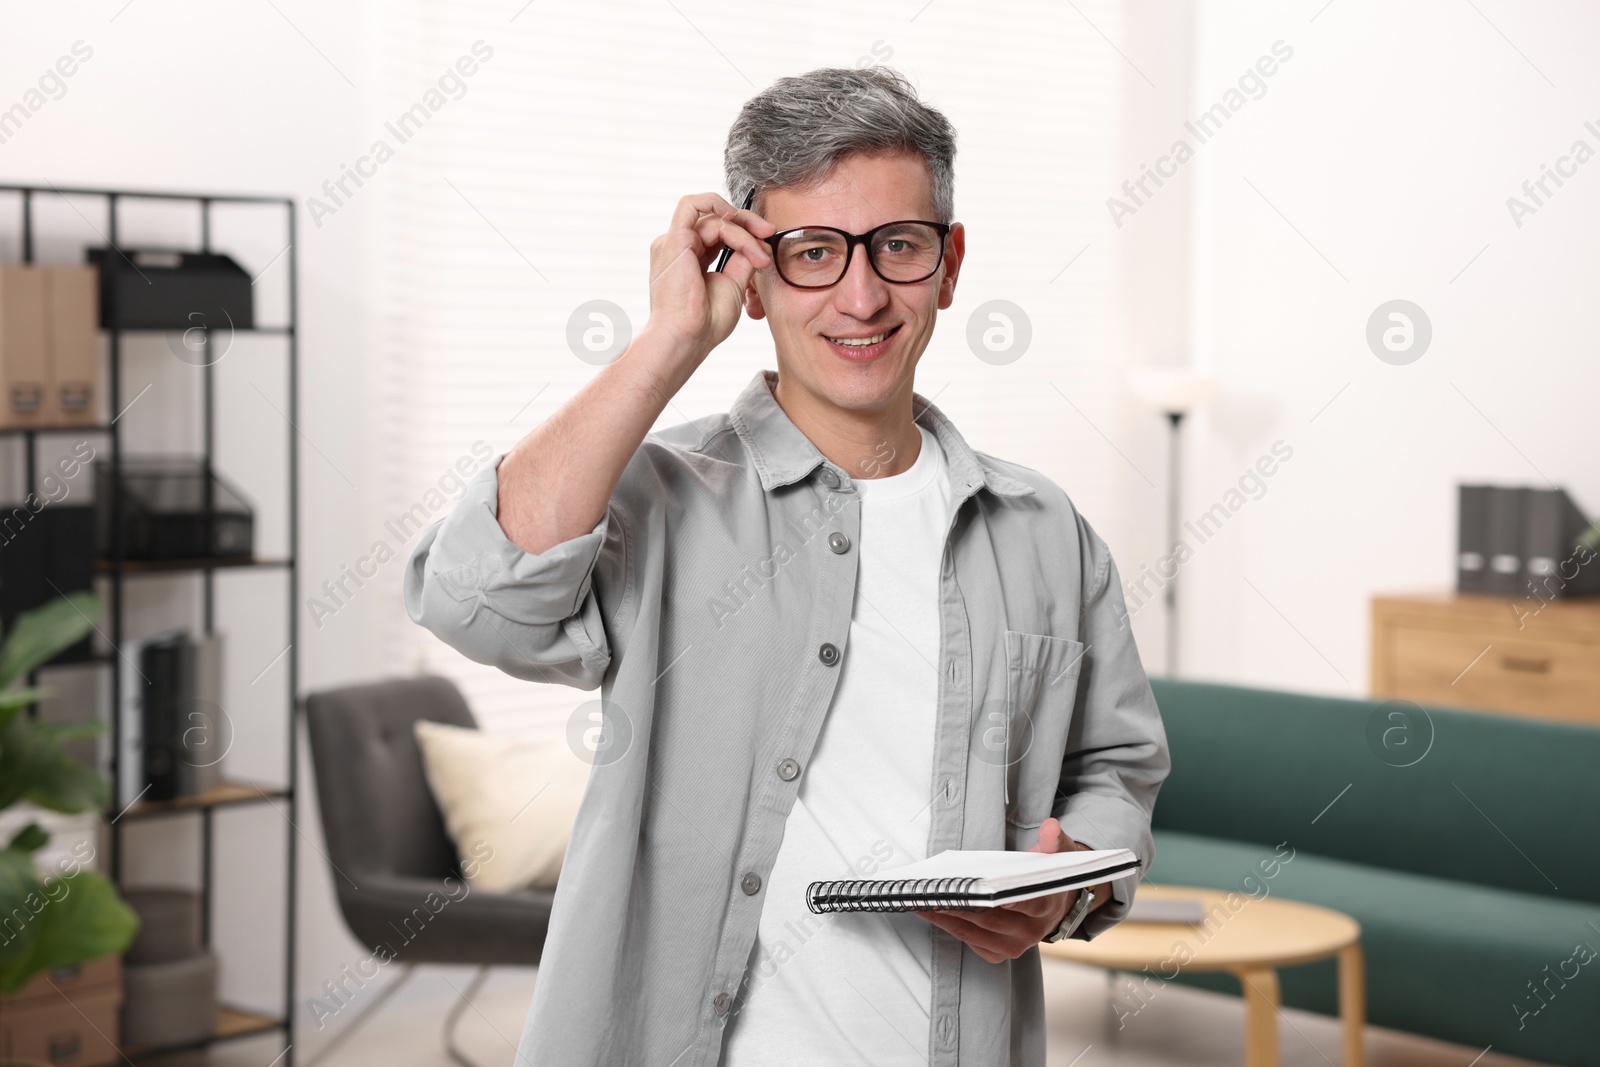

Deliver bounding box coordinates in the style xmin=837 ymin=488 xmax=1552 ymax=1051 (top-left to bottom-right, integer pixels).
xmin=728 ymin=370 xmax=1034 ymax=499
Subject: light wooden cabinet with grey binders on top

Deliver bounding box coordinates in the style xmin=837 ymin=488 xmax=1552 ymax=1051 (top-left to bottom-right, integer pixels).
xmin=1371 ymin=593 xmax=1600 ymax=725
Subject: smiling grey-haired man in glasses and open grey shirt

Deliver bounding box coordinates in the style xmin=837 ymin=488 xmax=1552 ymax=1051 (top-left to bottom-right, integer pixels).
xmin=405 ymin=67 xmax=1168 ymax=1067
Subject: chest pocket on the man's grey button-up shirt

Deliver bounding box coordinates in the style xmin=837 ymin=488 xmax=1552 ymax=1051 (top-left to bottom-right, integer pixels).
xmin=994 ymin=630 xmax=1085 ymax=827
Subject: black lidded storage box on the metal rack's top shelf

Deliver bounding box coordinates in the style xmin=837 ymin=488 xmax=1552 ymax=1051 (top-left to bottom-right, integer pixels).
xmin=86 ymin=248 xmax=256 ymax=330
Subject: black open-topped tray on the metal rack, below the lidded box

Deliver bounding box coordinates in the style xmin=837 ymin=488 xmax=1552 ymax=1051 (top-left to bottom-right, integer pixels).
xmin=94 ymin=456 xmax=254 ymax=560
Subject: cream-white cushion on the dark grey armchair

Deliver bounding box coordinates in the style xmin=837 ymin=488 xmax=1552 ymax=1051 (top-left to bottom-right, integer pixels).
xmin=414 ymin=720 xmax=589 ymax=893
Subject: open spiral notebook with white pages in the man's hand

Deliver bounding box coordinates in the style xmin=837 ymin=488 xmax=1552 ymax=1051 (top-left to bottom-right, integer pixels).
xmin=805 ymin=848 xmax=1139 ymax=913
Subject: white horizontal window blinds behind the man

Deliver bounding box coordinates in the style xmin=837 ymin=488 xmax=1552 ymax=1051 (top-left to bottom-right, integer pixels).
xmin=376 ymin=0 xmax=1131 ymax=733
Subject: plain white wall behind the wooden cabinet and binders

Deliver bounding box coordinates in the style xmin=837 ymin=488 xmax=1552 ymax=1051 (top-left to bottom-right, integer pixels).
xmin=1114 ymin=0 xmax=1600 ymax=693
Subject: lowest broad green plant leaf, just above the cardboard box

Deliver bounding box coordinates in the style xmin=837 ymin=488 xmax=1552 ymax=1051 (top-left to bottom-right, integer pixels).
xmin=0 ymin=870 xmax=139 ymax=993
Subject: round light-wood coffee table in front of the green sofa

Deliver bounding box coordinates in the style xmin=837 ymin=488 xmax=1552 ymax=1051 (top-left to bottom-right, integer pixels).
xmin=1038 ymin=883 xmax=1366 ymax=1067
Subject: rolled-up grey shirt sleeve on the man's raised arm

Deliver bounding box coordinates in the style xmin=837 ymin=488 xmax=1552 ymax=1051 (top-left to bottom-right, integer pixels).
xmin=403 ymin=453 xmax=627 ymax=689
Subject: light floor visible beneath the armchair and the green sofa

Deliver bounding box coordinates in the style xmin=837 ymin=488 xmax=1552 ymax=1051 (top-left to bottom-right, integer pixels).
xmin=190 ymin=960 xmax=1533 ymax=1067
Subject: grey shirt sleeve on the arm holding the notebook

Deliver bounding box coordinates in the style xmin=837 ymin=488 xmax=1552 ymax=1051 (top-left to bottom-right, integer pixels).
xmin=1053 ymin=517 xmax=1171 ymax=939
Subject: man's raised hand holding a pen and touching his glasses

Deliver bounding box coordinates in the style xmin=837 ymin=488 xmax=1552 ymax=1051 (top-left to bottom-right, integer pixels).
xmin=645 ymin=192 xmax=778 ymax=369
